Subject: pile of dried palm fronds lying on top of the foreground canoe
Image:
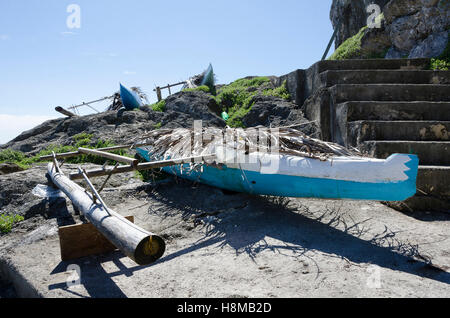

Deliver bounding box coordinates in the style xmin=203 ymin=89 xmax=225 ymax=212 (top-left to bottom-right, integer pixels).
xmin=136 ymin=127 xmax=361 ymax=160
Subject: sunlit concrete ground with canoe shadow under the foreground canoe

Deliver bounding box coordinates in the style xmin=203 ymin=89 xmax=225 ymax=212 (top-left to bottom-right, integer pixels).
xmin=0 ymin=169 xmax=450 ymax=298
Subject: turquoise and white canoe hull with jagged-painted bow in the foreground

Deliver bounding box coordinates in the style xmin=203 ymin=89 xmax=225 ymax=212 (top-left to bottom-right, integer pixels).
xmin=138 ymin=149 xmax=419 ymax=201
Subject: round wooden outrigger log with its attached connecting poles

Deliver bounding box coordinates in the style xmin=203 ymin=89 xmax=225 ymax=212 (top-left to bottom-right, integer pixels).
xmin=46 ymin=145 xmax=216 ymax=265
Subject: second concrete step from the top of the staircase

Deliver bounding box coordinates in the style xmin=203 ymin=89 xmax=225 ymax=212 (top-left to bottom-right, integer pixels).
xmin=320 ymin=70 xmax=450 ymax=87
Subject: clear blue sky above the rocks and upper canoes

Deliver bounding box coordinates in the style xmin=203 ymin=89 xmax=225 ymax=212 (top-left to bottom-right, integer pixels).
xmin=0 ymin=0 xmax=333 ymax=143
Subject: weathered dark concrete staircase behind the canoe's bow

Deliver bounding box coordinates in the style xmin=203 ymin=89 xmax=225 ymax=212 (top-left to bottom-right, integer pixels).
xmin=281 ymin=59 xmax=450 ymax=210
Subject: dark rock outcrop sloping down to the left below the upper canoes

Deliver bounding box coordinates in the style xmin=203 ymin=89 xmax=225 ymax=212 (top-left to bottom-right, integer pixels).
xmin=0 ymin=91 xmax=226 ymax=155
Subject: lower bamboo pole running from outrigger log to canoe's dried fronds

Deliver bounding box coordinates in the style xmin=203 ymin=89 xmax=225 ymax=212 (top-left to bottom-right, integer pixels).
xmin=70 ymin=155 xmax=216 ymax=180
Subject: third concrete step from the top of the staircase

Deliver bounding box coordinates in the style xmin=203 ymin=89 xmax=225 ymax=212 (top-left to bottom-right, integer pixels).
xmin=330 ymin=84 xmax=450 ymax=104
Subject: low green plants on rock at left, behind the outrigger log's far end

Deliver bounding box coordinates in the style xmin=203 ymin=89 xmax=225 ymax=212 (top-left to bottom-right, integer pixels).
xmin=0 ymin=133 xmax=128 ymax=169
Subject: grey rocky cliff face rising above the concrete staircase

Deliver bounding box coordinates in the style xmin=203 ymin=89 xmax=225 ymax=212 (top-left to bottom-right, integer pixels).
xmin=330 ymin=0 xmax=450 ymax=58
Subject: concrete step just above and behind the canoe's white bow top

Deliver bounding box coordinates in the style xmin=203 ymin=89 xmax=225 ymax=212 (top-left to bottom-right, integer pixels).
xmin=361 ymin=140 xmax=450 ymax=166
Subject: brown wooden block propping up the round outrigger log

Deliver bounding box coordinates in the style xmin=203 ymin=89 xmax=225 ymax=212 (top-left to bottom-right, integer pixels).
xmin=58 ymin=216 xmax=134 ymax=261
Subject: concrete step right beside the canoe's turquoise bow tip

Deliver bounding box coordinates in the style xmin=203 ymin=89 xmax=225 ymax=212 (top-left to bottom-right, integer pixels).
xmin=417 ymin=166 xmax=450 ymax=200
